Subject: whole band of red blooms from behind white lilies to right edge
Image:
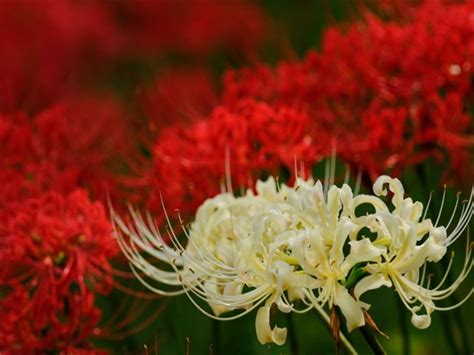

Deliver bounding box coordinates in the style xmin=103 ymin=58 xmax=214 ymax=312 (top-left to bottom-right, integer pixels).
xmin=149 ymin=2 xmax=474 ymax=220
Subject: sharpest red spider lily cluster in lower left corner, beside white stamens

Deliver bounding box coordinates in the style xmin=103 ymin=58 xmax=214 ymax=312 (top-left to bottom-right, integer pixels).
xmin=0 ymin=190 xmax=117 ymax=351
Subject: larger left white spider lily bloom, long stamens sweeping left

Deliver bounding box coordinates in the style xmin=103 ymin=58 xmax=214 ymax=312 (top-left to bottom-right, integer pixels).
xmin=113 ymin=178 xmax=366 ymax=344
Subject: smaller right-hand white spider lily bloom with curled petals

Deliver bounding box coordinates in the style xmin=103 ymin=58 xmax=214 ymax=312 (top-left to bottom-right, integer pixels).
xmin=352 ymin=176 xmax=474 ymax=329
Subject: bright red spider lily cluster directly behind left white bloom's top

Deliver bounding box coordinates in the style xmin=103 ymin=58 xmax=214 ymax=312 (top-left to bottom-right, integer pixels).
xmin=149 ymin=100 xmax=330 ymax=220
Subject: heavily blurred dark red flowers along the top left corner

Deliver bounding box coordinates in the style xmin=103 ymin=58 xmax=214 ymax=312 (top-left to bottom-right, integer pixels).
xmin=0 ymin=0 xmax=266 ymax=112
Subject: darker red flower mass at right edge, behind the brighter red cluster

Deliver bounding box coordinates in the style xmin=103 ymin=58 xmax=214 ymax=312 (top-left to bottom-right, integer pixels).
xmin=223 ymin=2 xmax=474 ymax=176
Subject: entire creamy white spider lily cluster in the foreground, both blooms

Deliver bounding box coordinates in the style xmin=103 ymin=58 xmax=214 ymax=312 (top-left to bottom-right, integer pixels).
xmin=114 ymin=176 xmax=474 ymax=344
